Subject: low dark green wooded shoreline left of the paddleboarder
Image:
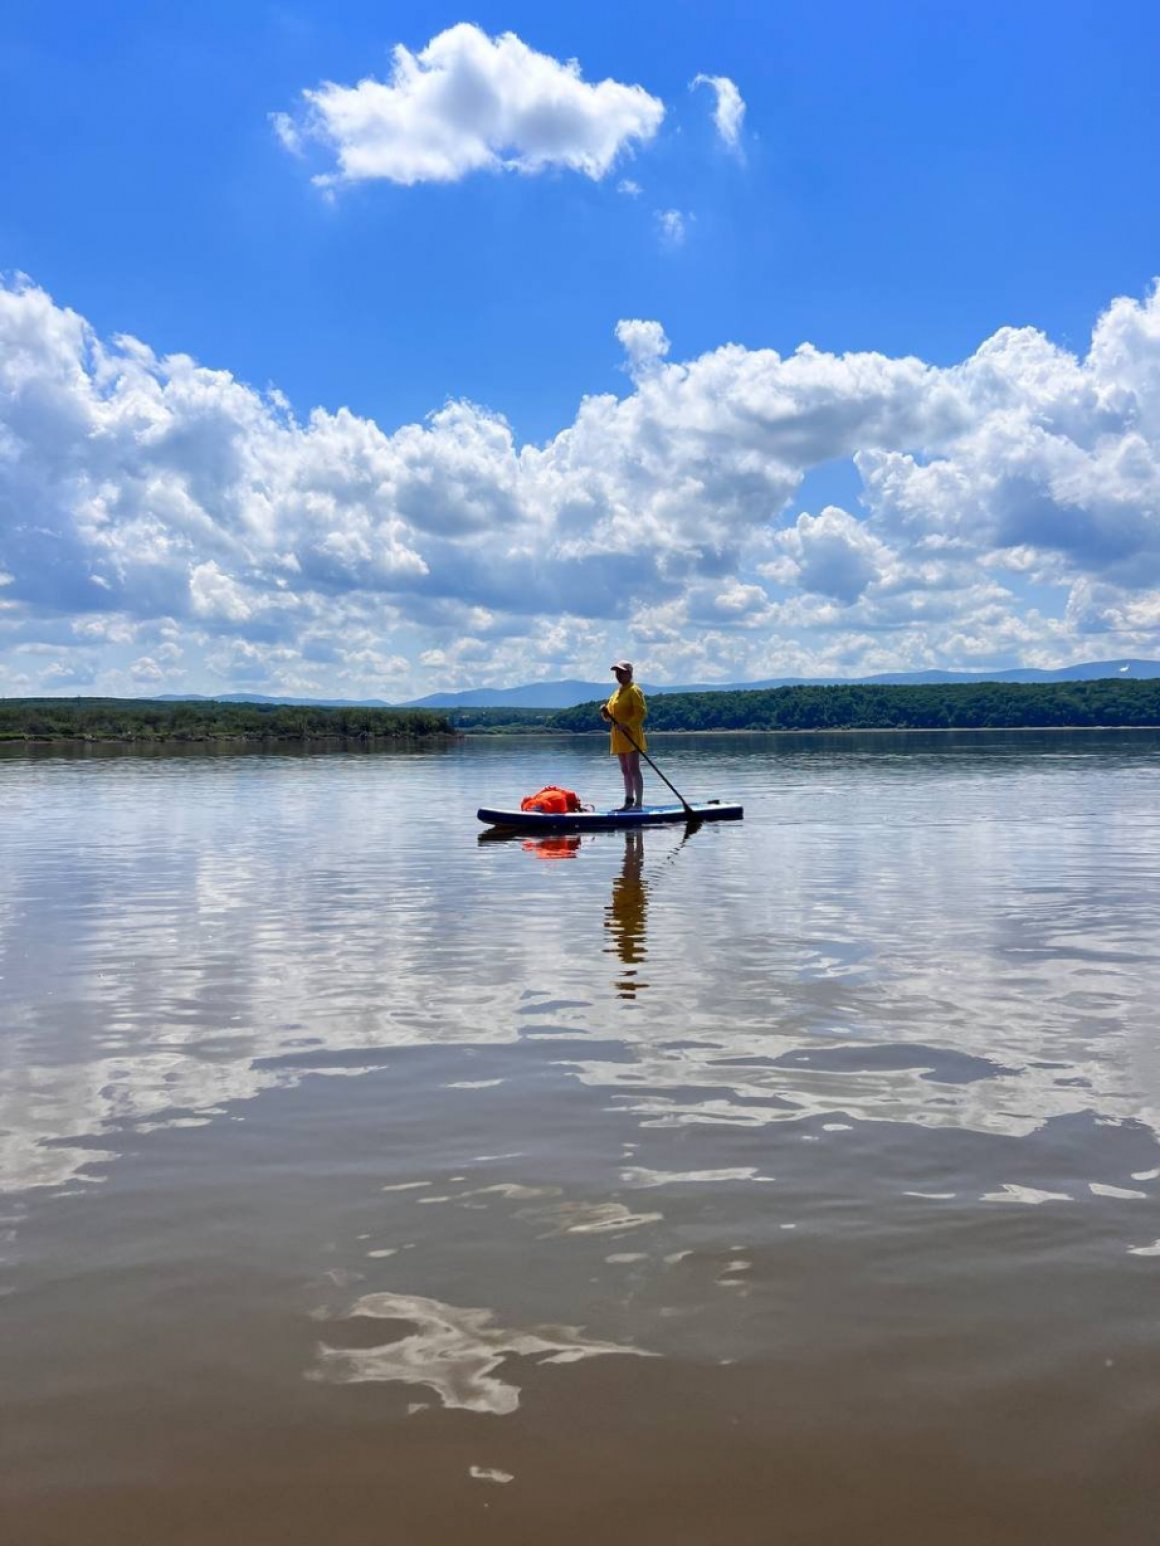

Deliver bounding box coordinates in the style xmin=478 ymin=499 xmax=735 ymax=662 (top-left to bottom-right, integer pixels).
xmin=0 ymin=697 xmax=456 ymax=744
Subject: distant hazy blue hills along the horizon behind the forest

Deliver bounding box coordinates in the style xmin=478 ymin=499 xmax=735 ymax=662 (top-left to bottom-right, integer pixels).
xmin=145 ymin=657 xmax=1160 ymax=710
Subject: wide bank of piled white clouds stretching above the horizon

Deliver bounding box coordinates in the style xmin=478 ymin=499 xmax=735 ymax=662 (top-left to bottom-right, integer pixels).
xmin=0 ymin=280 xmax=1160 ymax=697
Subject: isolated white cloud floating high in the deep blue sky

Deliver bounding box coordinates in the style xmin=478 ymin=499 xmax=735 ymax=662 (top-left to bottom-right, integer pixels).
xmin=274 ymin=22 xmax=665 ymax=186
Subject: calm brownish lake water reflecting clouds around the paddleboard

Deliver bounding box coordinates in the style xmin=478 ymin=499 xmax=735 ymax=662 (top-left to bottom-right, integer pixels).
xmin=0 ymin=736 xmax=1160 ymax=1546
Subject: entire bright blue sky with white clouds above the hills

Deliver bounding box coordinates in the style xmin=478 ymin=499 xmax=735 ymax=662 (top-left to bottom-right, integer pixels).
xmin=0 ymin=0 xmax=1160 ymax=699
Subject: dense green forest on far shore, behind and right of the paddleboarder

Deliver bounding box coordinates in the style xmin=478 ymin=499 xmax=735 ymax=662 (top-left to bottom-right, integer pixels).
xmin=546 ymin=677 xmax=1160 ymax=731
